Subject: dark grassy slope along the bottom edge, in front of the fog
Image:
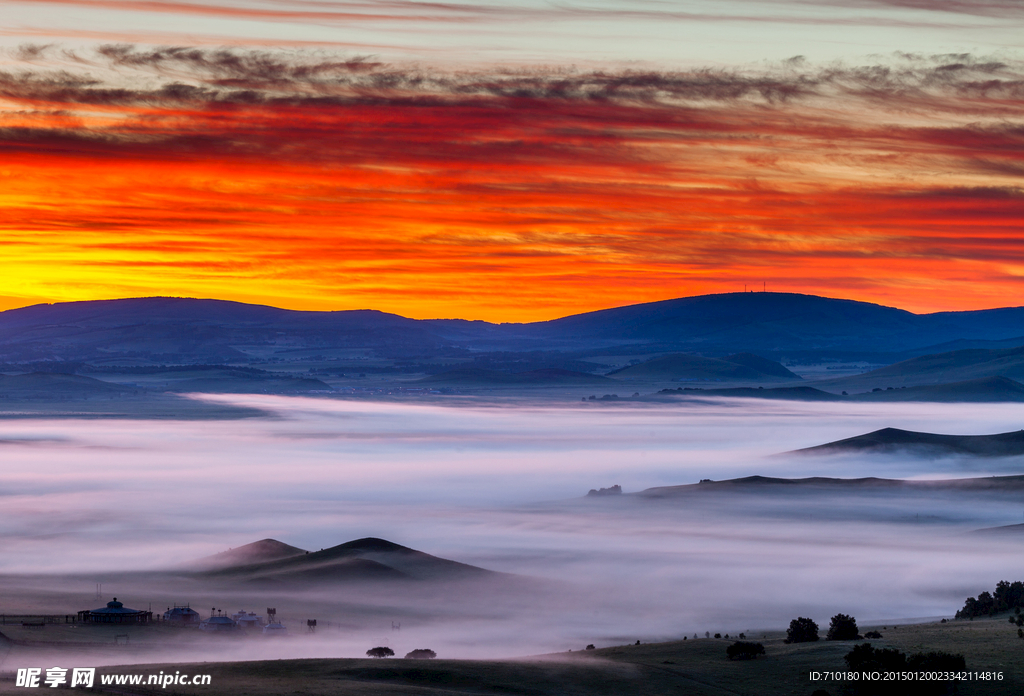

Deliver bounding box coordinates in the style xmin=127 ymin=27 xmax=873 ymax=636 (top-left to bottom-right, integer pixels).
xmin=0 ymin=616 xmax=1024 ymax=696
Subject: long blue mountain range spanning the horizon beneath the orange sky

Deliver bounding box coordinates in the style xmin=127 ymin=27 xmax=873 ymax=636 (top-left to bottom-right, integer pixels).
xmin=6 ymin=293 xmax=1024 ymax=364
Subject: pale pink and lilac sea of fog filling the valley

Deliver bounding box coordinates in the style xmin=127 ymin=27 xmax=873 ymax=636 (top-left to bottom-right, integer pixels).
xmin=0 ymin=395 xmax=1024 ymax=658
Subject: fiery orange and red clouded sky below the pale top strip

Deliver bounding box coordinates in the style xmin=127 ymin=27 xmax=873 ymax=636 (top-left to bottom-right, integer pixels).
xmin=0 ymin=46 xmax=1024 ymax=321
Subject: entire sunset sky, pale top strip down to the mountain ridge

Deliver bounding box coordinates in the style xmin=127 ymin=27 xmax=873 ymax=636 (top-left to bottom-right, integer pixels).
xmin=0 ymin=0 xmax=1024 ymax=321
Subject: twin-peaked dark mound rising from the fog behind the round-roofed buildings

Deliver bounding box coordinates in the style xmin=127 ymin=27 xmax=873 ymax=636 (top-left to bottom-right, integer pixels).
xmin=204 ymin=537 xmax=500 ymax=583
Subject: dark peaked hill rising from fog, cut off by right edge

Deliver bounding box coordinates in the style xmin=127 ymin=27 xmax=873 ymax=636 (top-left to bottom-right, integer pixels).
xmin=796 ymin=428 xmax=1024 ymax=456
